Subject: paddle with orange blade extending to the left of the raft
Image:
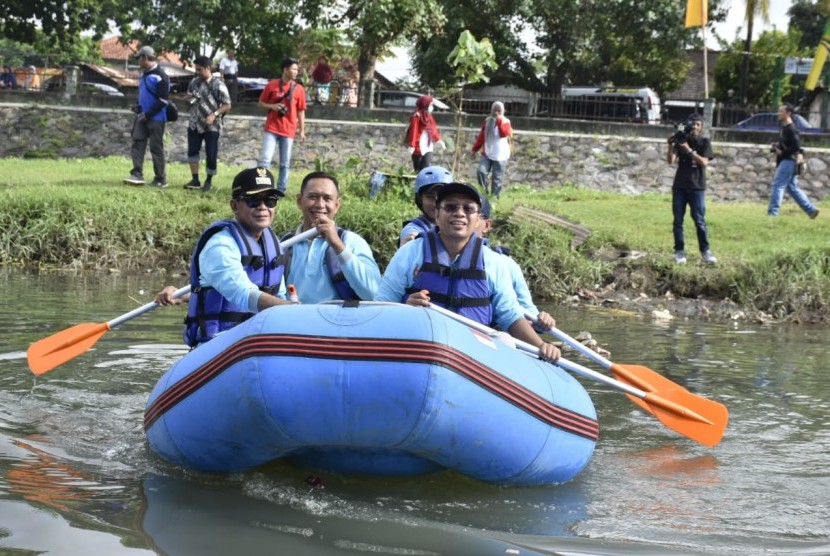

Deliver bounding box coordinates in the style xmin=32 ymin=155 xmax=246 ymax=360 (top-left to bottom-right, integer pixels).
xmin=26 ymin=228 xmax=319 ymax=375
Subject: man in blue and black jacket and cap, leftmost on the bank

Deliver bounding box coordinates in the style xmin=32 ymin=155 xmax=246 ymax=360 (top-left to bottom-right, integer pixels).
xmin=124 ymin=46 xmax=170 ymax=187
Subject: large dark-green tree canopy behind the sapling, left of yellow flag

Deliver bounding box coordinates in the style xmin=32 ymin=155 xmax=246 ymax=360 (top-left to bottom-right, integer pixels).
xmin=414 ymin=0 xmax=726 ymax=94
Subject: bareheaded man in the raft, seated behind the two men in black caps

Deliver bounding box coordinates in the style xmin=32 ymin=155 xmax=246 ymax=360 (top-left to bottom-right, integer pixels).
xmin=282 ymin=172 xmax=380 ymax=303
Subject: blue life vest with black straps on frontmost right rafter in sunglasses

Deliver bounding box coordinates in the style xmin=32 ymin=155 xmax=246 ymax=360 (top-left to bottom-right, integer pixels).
xmin=402 ymin=230 xmax=493 ymax=326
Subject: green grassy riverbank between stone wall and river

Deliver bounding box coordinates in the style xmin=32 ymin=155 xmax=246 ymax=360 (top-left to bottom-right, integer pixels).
xmin=0 ymin=158 xmax=830 ymax=322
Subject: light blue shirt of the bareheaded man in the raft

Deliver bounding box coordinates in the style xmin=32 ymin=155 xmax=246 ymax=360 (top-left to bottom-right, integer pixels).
xmin=287 ymin=227 xmax=380 ymax=303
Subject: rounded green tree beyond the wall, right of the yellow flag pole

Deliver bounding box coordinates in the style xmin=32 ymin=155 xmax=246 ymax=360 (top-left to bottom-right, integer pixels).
xmin=714 ymin=31 xmax=809 ymax=107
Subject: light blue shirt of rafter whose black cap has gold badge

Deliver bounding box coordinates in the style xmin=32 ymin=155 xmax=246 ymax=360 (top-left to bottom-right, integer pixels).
xmin=199 ymin=228 xmax=285 ymax=313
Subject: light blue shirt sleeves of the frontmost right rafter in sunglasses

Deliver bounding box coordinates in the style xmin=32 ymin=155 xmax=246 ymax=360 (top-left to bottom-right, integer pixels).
xmin=375 ymin=237 xmax=524 ymax=330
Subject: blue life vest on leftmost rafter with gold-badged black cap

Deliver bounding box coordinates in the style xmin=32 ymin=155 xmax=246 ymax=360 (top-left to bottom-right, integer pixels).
xmin=184 ymin=220 xmax=285 ymax=347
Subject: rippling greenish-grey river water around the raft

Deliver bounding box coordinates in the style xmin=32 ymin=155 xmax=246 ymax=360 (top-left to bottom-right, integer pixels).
xmin=0 ymin=271 xmax=830 ymax=556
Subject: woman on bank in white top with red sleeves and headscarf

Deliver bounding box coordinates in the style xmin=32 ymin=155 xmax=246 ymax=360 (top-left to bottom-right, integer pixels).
xmin=472 ymin=101 xmax=513 ymax=199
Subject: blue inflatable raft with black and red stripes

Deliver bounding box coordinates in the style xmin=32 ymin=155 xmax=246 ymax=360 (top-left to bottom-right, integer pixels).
xmin=144 ymin=303 xmax=598 ymax=485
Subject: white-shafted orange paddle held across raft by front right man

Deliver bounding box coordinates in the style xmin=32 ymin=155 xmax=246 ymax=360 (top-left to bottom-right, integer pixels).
xmin=430 ymin=305 xmax=729 ymax=446
